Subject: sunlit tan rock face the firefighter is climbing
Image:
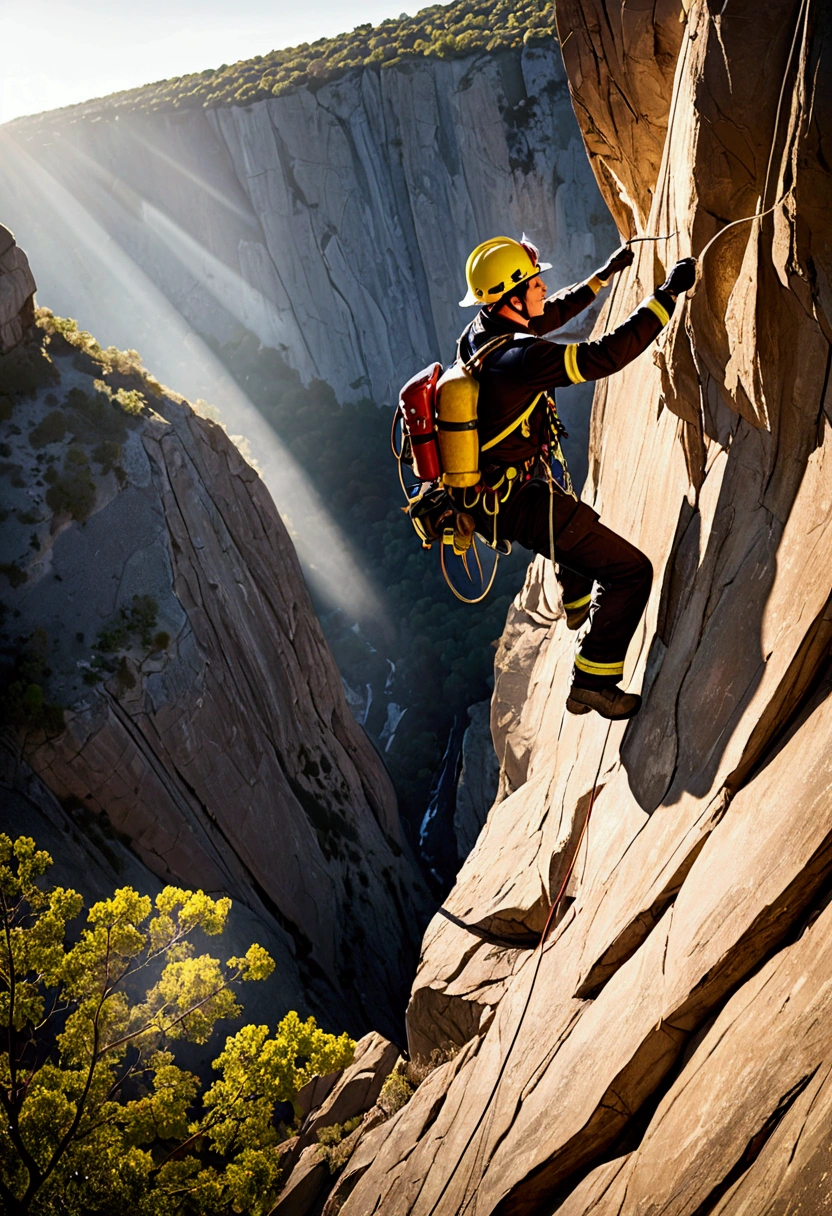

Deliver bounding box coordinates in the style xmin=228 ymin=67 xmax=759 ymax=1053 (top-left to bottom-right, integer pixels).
xmin=328 ymin=0 xmax=832 ymax=1216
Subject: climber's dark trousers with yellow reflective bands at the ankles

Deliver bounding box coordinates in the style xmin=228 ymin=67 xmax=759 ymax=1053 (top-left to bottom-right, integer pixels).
xmin=457 ymin=478 xmax=653 ymax=688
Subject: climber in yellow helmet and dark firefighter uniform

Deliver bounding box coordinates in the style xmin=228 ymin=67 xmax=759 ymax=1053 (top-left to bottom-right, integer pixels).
xmin=451 ymin=237 xmax=696 ymax=719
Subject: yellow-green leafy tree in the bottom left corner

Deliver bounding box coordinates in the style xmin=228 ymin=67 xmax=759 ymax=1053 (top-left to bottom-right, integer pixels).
xmin=0 ymin=835 xmax=355 ymax=1216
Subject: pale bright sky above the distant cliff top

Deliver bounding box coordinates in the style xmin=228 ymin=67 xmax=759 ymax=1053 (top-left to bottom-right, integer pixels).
xmin=0 ymin=0 xmax=447 ymax=123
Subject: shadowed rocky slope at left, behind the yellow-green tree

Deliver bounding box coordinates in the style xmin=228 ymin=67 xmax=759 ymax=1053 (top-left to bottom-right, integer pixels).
xmin=0 ymin=229 xmax=426 ymax=1034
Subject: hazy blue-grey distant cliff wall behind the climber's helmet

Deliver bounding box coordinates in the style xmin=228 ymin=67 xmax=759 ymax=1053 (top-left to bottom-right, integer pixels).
xmin=0 ymin=43 xmax=615 ymax=406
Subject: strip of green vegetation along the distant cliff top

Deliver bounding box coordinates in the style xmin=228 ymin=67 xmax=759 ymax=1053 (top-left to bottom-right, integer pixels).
xmin=14 ymin=0 xmax=553 ymax=119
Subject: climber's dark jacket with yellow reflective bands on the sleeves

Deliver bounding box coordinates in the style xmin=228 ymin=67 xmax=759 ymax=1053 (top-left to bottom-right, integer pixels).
xmin=459 ymin=283 xmax=674 ymax=468
